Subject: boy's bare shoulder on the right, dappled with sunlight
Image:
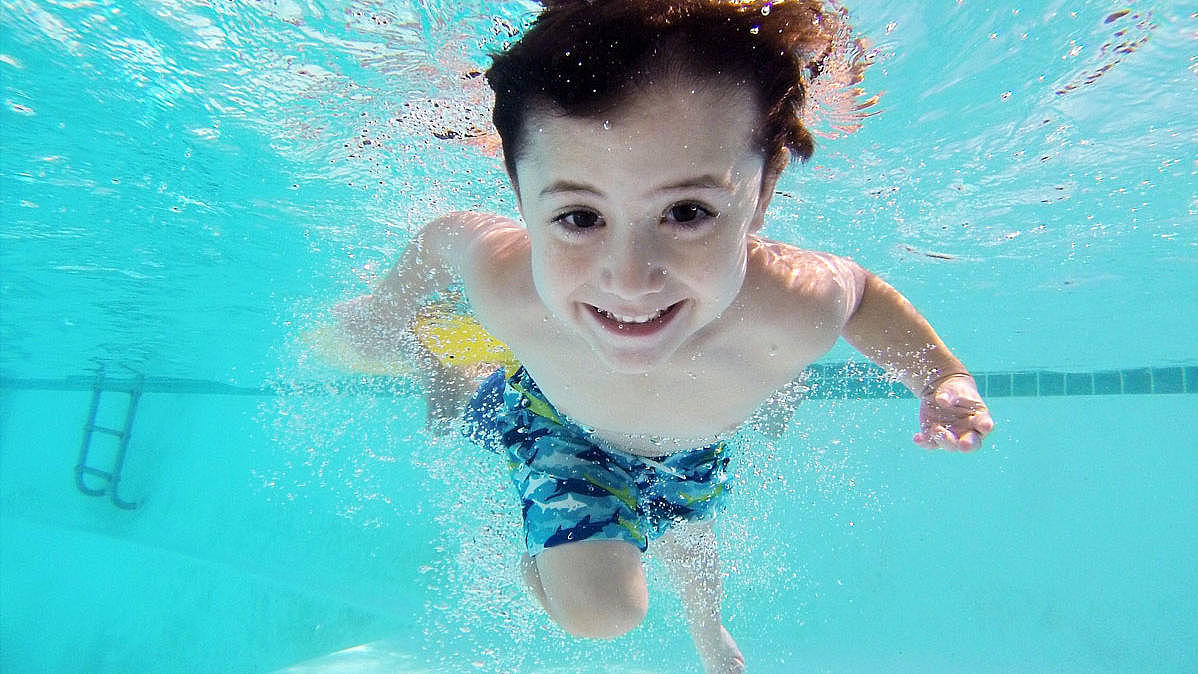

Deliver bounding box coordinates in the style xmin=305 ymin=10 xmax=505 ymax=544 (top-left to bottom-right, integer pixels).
xmin=745 ymin=237 xmax=866 ymax=341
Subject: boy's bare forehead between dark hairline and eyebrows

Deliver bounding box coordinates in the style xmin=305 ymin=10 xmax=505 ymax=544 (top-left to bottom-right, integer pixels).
xmin=516 ymin=77 xmax=762 ymax=188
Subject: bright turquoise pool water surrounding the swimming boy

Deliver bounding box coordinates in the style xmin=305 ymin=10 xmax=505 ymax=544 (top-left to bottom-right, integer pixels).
xmin=0 ymin=0 xmax=1198 ymax=672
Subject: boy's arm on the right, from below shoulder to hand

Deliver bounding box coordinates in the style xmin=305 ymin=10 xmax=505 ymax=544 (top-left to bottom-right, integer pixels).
xmin=842 ymin=265 xmax=994 ymax=451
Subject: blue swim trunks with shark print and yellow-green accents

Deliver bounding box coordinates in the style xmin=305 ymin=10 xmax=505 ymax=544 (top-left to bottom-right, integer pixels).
xmin=462 ymin=366 xmax=730 ymax=557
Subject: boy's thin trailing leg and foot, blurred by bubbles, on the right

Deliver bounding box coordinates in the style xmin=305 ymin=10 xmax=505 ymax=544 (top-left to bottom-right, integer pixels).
xmin=651 ymin=520 xmax=745 ymax=673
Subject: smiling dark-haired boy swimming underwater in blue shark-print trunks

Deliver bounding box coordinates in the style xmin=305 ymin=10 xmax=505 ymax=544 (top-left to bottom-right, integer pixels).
xmin=339 ymin=0 xmax=993 ymax=672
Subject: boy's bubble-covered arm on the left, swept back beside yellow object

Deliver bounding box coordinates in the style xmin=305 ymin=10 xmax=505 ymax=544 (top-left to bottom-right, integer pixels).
xmin=333 ymin=212 xmax=512 ymax=362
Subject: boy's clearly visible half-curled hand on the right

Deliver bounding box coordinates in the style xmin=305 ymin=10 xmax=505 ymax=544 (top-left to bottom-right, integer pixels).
xmin=912 ymin=375 xmax=994 ymax=451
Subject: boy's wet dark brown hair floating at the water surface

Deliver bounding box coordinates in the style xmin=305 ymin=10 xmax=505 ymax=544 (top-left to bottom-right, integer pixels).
xmin=486 ymin=0 xmax=840 ymax=182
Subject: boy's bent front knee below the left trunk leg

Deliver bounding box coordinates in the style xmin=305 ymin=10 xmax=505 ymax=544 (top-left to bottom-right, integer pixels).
xmin=522 ymin=541 xmax=649 ymax=638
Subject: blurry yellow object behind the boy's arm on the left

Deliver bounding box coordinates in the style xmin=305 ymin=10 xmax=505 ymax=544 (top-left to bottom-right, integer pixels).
xmin=301 ymin=302 xmax=516 ymax=376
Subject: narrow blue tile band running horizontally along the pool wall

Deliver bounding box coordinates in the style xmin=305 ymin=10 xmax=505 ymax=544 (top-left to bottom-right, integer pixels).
xmin=0 ymin=362 xmax=1198 ymax=400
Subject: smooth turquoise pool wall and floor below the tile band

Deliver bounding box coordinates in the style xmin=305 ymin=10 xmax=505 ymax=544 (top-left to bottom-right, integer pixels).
xmin=0 ymin=380 xmax=1198 ymax=672
